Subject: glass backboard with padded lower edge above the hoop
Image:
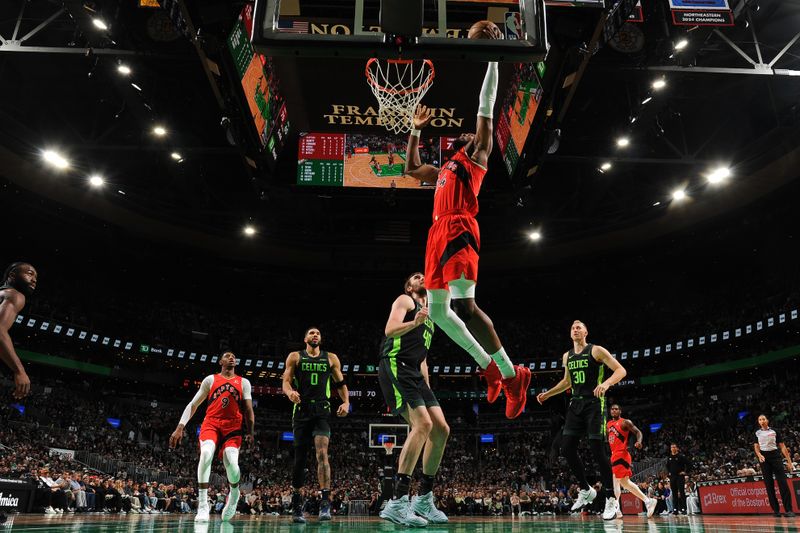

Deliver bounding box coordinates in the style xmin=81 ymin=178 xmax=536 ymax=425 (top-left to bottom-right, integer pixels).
xmin=251 ymin=0 xmax=548 ymax=62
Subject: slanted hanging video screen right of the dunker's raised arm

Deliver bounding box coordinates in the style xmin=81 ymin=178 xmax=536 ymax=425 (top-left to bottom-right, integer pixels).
xmin=495 ymin=63 xmax=545 ymax=175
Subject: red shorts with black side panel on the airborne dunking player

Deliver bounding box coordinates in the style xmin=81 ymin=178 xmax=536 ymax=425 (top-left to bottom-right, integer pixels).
xmin=425 ymin=215 xmax=481 ymax=290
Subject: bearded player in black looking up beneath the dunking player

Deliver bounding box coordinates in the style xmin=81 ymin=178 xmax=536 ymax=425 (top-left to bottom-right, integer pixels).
xmin=378 ymin=272 xmax=450 ymax=527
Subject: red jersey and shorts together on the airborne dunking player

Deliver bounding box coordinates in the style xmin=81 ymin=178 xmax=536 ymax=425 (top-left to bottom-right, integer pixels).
xmin=425 ymin=148 xmax=486 ymax=289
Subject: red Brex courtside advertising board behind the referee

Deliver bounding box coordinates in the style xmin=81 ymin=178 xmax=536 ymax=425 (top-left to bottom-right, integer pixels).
xmin=698 ymin=476 xmax=800 ymax=514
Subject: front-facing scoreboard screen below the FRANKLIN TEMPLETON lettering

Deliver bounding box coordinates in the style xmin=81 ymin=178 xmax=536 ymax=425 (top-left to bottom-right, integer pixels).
xmin=297 ymin=133 xmax=456 ymax=189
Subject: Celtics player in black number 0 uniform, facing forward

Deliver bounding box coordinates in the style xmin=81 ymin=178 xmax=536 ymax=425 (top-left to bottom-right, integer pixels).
xmin=283 ymin=328 xmax=350 ymax=523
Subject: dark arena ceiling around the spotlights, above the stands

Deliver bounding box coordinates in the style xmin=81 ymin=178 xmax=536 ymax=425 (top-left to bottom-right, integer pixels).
xmin=0 ymin=0 xmax=800 ymax=268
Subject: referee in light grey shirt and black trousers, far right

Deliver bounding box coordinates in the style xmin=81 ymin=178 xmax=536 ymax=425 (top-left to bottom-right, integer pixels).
xmin=753 ymin=415 xmax=794 ymax=516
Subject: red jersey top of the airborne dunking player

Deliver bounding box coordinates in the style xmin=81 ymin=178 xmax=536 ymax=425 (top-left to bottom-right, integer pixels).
xmin=433 ymin=148 xmax=486 ymax=221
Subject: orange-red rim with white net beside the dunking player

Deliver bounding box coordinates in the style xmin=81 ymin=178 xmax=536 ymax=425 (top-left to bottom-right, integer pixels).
xmin=364 ymin=57 xmax=435 ymax=133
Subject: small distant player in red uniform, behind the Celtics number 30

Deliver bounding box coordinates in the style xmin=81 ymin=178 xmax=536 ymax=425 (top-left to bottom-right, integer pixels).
xmin=606 ymin=403 xmax=658 ymax=518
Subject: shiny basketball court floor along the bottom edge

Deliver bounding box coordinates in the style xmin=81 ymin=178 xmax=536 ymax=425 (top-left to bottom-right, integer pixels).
xmin=0 ymin=515 xmax=800 ymax=533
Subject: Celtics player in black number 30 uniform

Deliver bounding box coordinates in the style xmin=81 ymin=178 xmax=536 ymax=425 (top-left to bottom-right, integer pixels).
xmin=536 ymin=320 xmax=627 ymax=520
